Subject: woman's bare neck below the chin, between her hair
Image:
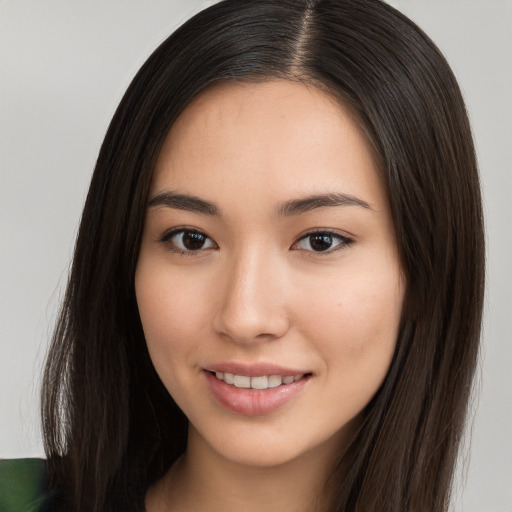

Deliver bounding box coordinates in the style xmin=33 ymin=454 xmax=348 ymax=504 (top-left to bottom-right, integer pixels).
xmin=146 ymin=428 xmax=350 ymax=512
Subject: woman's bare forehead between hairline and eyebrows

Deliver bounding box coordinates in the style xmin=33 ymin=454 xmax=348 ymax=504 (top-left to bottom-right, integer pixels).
xmin=152 ymin=80 xmax=384 ymax=210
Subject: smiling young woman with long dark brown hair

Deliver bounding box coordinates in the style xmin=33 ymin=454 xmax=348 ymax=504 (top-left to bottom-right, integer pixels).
xmin=0 ymin=0 xmax=484 ymax=512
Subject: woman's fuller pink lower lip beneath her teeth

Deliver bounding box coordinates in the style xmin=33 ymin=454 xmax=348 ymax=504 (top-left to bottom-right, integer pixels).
xmin=204 ymin=371 xmax=309 ymax=416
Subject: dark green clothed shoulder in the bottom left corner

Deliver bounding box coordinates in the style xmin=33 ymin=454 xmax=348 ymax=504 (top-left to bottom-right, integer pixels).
xmin=0 ymin=459 xmax=55 ymax=512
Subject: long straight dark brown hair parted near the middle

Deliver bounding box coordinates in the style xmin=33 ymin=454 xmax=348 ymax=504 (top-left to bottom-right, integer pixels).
xmin=42 ymin=0 xmax=484 ymax=512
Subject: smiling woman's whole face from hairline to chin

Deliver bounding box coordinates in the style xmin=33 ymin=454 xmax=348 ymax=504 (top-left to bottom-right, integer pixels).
xmin=135 ymin=80 xmax=404 ymax=466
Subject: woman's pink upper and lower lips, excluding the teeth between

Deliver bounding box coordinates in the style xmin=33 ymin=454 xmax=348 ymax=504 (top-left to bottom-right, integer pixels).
xmin=203 ymin=363 xmax=311 ymax=416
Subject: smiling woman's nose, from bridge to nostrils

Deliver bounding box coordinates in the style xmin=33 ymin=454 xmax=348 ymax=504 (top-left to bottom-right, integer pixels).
xmin=214 ymin=250 xmax=290 ymax=343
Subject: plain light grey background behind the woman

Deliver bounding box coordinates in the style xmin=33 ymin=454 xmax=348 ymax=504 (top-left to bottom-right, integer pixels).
xmin=0 ymin=0 xmax=512 ymax=512
